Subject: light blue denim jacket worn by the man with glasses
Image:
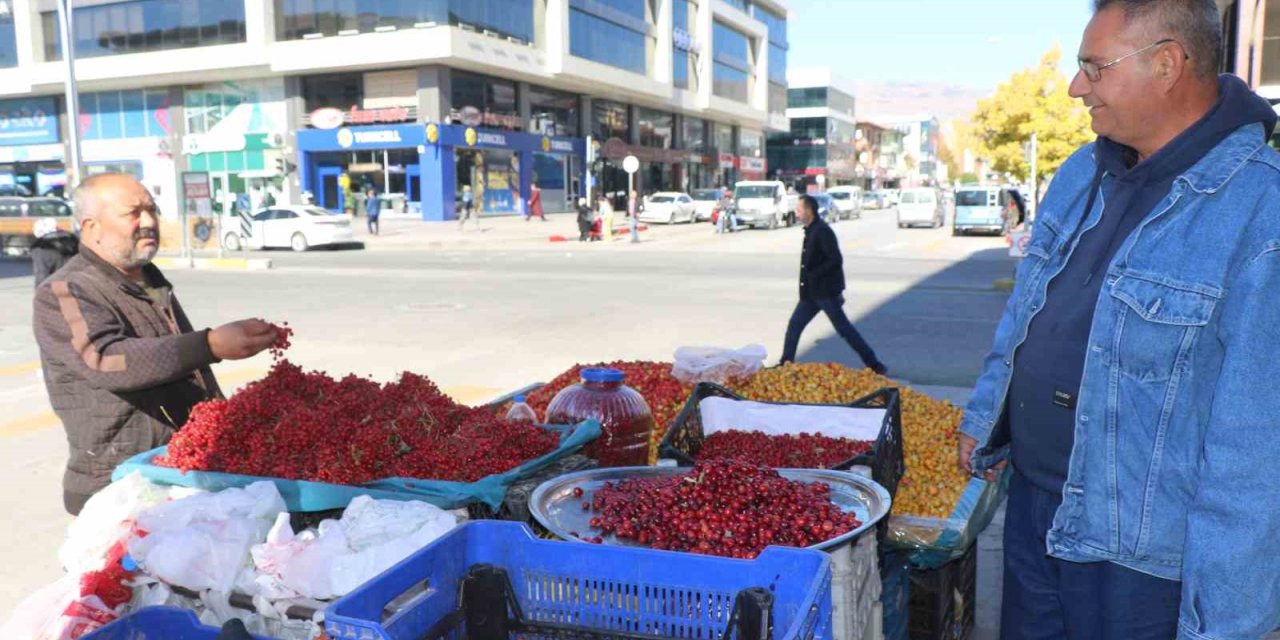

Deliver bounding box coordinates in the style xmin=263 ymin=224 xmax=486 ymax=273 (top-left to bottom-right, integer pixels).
xmin=961 ymin=124 xmax=1280 ymax=640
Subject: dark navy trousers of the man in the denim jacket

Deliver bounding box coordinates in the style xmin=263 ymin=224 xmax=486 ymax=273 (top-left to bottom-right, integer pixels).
xmin=1000 ymin=472 xmax=1183 ymax=640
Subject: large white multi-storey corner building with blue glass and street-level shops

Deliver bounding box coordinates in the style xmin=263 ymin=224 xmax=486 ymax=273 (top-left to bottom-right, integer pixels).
xmin=0 ymin=0 xmax=787 ymax=220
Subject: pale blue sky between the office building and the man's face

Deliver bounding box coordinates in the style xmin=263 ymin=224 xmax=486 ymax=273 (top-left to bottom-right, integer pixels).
xmin=786 ymin=0 xmax=1092 ymax=90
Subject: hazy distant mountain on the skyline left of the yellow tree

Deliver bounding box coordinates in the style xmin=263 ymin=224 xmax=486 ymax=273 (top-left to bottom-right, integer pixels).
xmin=855 ymin=82 xmax=995 ymax=122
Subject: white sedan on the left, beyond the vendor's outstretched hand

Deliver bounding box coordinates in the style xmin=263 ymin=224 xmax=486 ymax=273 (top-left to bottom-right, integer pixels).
xmin=223 ymin=205 xmax=356 ymax=251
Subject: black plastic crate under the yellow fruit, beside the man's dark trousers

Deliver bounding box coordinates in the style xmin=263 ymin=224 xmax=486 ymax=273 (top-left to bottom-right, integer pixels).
xmin=908 ymin=544 xmax=978 ymax=640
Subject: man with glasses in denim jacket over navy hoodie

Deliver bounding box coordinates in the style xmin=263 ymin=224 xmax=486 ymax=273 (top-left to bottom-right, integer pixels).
xmin=959 ymin=0 xmax=1280 ymax=640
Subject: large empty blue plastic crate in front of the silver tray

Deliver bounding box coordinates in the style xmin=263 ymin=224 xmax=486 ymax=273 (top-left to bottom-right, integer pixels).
xmin=325 ymin=521 xmax=831 ymax=640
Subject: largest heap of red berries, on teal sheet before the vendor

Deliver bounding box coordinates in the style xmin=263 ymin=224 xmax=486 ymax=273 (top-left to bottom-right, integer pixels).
xmin=156 ymin=358 xmax=559 ymax=485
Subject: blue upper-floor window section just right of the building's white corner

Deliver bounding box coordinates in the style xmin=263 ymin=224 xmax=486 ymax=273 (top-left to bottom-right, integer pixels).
xmin=568 ymin=0 xmax=653 ymax=73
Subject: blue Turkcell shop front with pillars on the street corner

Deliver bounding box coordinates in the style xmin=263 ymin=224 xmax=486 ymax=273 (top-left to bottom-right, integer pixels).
xmin=297 ymin=123 xmax=586 ymax=220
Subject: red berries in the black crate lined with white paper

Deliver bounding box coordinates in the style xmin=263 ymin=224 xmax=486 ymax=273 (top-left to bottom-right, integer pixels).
xmin=698 ymin=429 xmax=872 ymax=468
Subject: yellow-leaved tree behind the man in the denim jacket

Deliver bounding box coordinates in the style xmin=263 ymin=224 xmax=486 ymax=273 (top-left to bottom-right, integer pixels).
xmin=973 ymin=45 xmax=1093 ymax=182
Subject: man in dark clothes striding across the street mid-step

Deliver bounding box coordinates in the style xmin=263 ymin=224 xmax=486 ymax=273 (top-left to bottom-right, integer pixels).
xmin=782 ymin=195 xmax=888 ymax=375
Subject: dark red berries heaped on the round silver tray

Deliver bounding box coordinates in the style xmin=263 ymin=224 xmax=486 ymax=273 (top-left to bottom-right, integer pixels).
xmin=575 ymin=460 xmax=861 ymax=558
